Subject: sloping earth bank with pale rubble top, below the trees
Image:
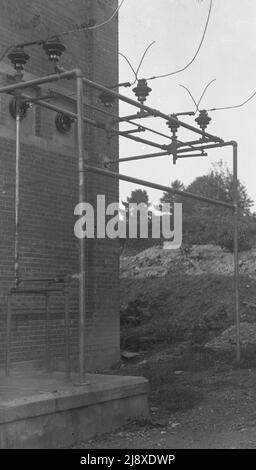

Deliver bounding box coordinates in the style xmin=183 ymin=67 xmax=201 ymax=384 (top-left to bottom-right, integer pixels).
xmin=120 ymin=245 xmax=256 ymax=351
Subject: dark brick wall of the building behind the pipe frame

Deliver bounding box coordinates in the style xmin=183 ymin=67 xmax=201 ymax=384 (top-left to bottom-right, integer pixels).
xmin=0 ymin=0 xmax=119 ymax=370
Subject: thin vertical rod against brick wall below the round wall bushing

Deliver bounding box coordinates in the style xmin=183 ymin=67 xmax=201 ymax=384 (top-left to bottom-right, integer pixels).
xmin=14 ymin=112 xmax=20 ymax=286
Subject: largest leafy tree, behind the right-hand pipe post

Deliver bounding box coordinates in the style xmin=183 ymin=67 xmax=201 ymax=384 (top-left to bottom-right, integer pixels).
xmin=161 ymin=161 xmax=253 ymax=250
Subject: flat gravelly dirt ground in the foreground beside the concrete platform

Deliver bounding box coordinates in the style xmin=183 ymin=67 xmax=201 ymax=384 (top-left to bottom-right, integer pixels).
xmin=77 ymin=365 xmax=256 ymax=450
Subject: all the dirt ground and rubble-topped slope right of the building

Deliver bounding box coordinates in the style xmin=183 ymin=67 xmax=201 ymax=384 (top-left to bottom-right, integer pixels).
xmin=78 ymin=246 xmax=256 ymax=448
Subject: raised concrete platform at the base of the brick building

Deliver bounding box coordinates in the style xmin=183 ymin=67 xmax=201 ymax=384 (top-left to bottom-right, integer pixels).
xmin=0 ymin=372 xmax=149 ymax=449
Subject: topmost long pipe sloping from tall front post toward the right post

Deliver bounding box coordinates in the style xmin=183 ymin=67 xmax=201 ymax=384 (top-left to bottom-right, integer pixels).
xmin=83 ymin=77 xmax=223 ymax=142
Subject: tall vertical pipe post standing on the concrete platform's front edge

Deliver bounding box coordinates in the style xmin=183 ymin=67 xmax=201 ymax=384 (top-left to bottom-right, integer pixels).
xmin=76 ymin=73 xmax=86 ymax=383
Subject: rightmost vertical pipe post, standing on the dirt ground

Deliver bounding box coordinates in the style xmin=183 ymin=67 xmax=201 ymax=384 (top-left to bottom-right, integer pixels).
xmin=232 ymin=142 xmax=241 ymax=361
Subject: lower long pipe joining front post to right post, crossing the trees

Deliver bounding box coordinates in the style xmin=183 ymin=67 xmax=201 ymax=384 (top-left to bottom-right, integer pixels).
xmin=84 ymin=164 xmax=235 ymax=210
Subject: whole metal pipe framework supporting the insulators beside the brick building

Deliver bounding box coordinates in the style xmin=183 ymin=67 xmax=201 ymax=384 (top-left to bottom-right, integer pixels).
xmin=0 ymin=69 xmax=240 ymax=374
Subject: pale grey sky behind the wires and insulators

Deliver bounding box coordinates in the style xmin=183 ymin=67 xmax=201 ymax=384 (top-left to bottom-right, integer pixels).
xmin=119 ymin=0 xmax=256 ymax=210
